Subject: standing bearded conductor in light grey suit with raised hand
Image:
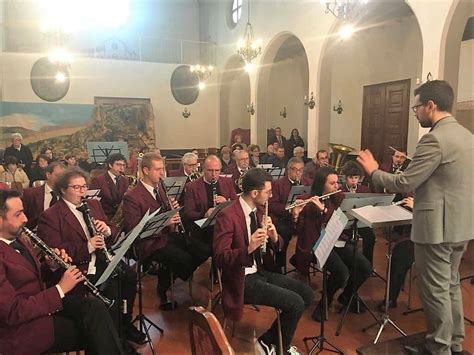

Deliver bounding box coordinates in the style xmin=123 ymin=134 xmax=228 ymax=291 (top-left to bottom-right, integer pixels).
xmin=357 ymin=80 xmax=474 ymax=354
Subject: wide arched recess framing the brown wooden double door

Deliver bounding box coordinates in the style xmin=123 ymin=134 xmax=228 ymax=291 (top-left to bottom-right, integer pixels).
xmin=317 ymin=1 xmax=423 ymax=159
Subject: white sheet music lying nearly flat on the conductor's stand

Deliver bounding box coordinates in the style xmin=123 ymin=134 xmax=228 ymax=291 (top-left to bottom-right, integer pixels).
xmin=351 ymin=205 xmax=413 ymax=228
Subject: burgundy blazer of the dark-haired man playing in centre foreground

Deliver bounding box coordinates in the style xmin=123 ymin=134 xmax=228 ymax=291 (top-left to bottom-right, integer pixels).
xmin=213 ymin=200 xmax=283 ymax=320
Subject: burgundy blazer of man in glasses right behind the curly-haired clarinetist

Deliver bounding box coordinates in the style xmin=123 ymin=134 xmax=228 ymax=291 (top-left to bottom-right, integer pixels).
xmin=90 ymin=172 xmax=129 ymax=219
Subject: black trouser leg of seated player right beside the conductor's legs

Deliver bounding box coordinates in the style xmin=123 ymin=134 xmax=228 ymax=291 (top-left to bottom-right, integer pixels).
xmin=389 ymin=239 xmax=415 ymax=301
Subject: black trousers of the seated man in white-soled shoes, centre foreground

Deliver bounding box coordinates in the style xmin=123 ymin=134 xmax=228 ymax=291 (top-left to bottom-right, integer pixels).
xmin=244 ymin=271 xmax=314 ymax=350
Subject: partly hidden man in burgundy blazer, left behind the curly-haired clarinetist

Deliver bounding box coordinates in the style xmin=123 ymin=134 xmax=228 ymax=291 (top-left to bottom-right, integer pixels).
xmin=22 ymin=161 xmax=64 ymax=230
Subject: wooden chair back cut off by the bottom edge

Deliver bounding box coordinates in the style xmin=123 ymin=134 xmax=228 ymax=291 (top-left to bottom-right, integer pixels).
xmin=189 ymin=306 xmax=235 ymax=355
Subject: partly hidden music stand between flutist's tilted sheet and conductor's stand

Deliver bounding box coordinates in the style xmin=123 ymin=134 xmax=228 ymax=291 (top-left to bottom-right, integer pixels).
xmin=336 ymin=193 xmax=395 ymax=336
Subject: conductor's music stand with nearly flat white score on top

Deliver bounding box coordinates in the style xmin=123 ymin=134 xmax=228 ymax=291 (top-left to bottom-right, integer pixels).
xmin=350 ymin=205 xmax=413 ymax=344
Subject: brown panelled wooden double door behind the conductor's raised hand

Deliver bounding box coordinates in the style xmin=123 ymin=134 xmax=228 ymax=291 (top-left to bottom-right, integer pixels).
xmin=361 ymin=80 xmax=410 ymax=163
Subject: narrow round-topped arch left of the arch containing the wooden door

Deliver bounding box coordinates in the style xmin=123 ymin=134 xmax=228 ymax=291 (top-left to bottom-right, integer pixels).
xmin=256 ymin=32 xmax=309 ymax=149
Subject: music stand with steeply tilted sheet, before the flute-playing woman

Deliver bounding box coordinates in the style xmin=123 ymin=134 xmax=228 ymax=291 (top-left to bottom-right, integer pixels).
xmin=303 ymin=208 xmax=347 ymax=354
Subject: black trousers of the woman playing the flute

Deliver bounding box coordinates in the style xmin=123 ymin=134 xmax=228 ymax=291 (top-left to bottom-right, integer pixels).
xmin=326 ymin=242 xmax=372 ymax=303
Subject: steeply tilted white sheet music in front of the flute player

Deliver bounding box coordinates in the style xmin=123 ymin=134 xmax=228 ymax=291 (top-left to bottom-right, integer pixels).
xmin=313 ymin=208 xmax=347 ymax=269
